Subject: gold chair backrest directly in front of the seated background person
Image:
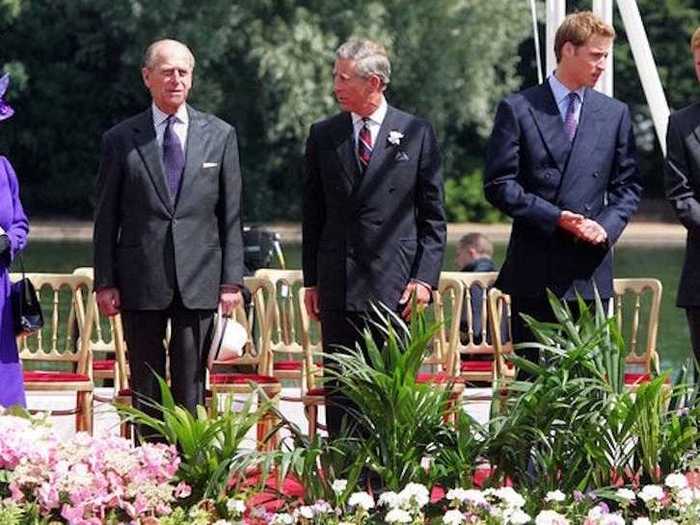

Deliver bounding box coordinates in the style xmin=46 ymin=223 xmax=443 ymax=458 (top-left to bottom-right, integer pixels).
xmin=440 ymin=272 xmax=500 ymax=355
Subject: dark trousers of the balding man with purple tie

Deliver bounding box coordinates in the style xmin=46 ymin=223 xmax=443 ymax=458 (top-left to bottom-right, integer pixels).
xmin=122 ymin=297 xmax=214 ymax=435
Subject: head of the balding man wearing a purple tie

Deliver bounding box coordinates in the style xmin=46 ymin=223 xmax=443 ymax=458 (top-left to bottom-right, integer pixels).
xmin=141 ymin=42 xmax=192 ymax=115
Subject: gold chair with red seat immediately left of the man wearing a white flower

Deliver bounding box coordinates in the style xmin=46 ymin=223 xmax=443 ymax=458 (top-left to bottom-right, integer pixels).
xmin=255 ymin=268 xmax=321 ymax=401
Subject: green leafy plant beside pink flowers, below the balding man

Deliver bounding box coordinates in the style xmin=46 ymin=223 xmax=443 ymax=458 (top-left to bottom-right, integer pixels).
xmin=117 ymin=377 xmax=271 ymax=502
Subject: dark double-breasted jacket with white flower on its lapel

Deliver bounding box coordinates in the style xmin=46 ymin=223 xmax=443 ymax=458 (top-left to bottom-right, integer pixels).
xmin=303 ymin=106 xmax=446 ymax=312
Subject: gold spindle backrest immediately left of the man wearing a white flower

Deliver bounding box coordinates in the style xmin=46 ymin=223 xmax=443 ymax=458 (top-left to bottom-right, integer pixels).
xmin=255 ymin=268 xmax=304 ymax=360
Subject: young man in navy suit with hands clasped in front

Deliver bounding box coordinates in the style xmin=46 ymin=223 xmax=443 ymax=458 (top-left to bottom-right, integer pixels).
xmin=484 ymin=12 xmax=641 ymax=372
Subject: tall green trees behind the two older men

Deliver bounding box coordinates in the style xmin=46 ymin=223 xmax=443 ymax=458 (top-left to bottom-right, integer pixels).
xmin=0 ymin=0 xmax=529 ymax=220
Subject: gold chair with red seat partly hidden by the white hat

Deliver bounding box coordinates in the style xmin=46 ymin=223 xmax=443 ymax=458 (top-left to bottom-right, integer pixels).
xmin=208 ymin=277 xmax=282 ymax=448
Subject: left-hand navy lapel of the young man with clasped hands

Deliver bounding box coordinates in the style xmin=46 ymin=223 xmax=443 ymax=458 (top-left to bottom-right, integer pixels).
xmin=530 ymin=82 xmax=571 ymax=173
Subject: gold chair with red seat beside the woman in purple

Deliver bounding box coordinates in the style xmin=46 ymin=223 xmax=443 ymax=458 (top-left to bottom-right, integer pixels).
xmin=10 ymin=273 xmax=95 ymax=433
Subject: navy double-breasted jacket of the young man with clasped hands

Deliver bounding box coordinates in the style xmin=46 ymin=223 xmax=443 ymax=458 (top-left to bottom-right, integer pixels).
xmin=484 ymin=82 xmax=641 ymax=299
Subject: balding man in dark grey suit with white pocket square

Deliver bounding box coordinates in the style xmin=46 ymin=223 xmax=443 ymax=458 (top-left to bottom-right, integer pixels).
xmin=94 ymin=40 xmax=243 ymax=428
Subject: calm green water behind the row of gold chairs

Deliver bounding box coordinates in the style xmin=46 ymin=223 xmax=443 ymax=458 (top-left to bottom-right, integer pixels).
xmin=24 ymin=241 xmax=690 ymax=369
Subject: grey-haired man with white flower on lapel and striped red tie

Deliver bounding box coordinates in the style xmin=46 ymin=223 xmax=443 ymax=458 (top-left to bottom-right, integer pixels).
xmin=303 ymin=40 xmax=445 ymax=436
